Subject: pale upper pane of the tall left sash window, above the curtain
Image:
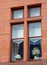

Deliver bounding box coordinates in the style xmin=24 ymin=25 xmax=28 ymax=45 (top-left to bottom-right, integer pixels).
xmin=12 ymin=24 xmax=24 ymax=38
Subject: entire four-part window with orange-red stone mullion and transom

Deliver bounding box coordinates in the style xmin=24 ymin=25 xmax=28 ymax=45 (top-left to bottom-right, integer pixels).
xmin=12 ymin=4 xmax=42 ymax=61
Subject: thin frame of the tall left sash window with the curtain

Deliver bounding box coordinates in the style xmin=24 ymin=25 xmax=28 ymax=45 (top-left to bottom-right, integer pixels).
xmin=11 ymin=23 xmax=24 ymax=62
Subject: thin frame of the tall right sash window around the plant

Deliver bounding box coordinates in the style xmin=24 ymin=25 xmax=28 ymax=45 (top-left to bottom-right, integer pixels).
xmin=28 ymin=20 xmax=42 ymax=61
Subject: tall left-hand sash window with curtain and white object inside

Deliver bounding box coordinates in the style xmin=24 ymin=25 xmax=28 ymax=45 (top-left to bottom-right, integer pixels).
xmin=12 ymin=24 xmax=24 ymax=61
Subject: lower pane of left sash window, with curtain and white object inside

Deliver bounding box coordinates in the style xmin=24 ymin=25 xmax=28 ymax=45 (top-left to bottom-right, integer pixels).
xmin=12 ymin=39 xmax=24 ymax=61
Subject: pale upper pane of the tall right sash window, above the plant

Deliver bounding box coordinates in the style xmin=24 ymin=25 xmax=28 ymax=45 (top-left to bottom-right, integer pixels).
xmin=29 ymin=22 xmax=41 ymax=37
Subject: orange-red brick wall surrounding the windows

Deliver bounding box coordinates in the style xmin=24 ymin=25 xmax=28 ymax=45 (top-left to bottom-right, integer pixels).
xmin=0 ymin=0 xmax=47 ymax=62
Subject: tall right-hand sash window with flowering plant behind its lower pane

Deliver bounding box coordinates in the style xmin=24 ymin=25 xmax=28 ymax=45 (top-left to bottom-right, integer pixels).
xmin=29 ymin=22 xmax=42 ymax=59
